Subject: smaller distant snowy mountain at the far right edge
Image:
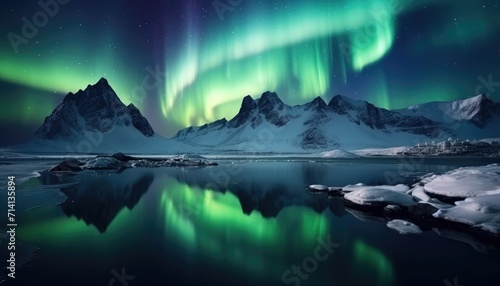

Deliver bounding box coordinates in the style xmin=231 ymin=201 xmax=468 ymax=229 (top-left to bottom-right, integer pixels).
xmin=397 ymin=94 xmax=500 ymax=139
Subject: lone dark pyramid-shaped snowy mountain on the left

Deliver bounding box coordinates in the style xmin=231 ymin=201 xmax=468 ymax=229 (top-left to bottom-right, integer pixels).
xmin=17 ymin=78 xmax=186 ymax=154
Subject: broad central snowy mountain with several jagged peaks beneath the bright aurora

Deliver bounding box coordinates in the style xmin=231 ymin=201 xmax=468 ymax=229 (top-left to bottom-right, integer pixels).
xmin=173 ymin=92 xmax=453 ymax=152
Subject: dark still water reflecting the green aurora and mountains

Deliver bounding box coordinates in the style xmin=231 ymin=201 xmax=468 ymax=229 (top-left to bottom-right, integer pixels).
xmin=2 ymin=158 xmax=500 ymax=286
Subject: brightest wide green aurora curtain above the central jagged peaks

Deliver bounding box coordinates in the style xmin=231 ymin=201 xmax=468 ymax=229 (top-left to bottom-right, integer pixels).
xmin=161 ymin=0 xmax=403 ymax=126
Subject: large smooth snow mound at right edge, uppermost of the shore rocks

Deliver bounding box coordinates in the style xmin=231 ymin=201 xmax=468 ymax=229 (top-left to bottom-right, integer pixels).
xmin=424 ymin=164 xmax=500 ymax=198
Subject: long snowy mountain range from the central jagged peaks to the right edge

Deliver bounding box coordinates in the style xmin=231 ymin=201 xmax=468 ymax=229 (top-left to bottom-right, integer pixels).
xmin=172 ymin=91 xmax=500 ymax=151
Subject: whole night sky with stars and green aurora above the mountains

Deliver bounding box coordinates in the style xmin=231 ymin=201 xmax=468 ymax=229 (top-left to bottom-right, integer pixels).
xmin=0 ymin=0 xmax=500 ymax=145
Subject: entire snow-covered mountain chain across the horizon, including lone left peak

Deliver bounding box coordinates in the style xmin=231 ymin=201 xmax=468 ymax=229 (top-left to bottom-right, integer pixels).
xmin=11 ymin=78 xmax=500 ymax=153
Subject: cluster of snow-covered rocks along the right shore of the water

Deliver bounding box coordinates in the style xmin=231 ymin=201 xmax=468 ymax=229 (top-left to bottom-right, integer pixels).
xmin=309 ymin=164 xmax=500 ymax=235
